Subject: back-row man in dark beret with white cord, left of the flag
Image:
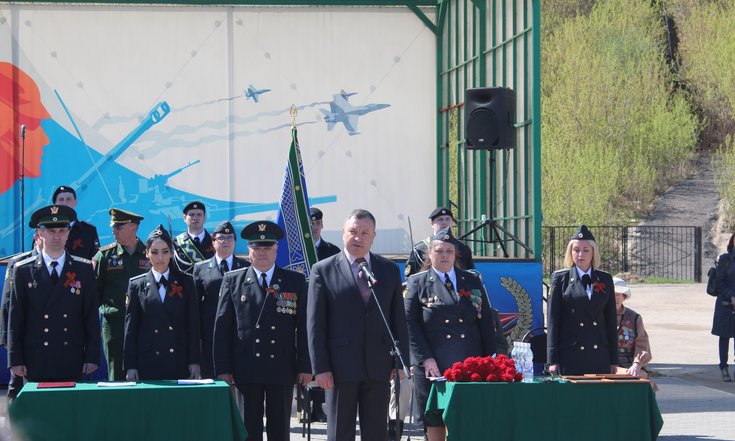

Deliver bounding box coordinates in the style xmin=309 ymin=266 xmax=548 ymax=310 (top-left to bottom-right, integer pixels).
xmin=174 ymin=201 xmax=215 ymax=274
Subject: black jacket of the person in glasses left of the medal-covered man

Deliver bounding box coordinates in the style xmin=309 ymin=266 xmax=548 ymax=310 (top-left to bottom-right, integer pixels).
xmin=193 ymin=256 xmax=250 ymax=377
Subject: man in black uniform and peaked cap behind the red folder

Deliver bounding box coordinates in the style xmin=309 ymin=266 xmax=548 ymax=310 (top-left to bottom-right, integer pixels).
xmin=8 ymin=205 xmax=100 ymax=381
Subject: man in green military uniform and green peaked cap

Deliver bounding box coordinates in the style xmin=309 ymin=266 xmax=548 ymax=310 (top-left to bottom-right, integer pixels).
xmin=92 ymin=208 xmax=150 ymax=381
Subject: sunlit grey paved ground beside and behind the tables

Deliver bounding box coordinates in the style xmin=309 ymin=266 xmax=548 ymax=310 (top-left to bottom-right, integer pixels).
xmin=0 ymin=284 xmax=735 ymax=441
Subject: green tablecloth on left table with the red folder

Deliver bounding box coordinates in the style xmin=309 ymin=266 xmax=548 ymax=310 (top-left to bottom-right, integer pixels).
xmin=9 ymin=381 xmax=247 ymax=441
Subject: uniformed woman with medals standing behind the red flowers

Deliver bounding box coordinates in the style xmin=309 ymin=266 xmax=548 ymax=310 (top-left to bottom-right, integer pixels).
xmin=404 ymin=231 xmax=496 ymax=441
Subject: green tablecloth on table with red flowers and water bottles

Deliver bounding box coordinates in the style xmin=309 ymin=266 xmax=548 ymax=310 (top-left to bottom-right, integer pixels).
xmin=426 ymin=382 xmax=663 ymax=441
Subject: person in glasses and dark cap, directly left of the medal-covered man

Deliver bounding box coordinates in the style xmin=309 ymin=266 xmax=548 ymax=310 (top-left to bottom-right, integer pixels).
xmin=193 ymin=221 xmax=250 ymax=378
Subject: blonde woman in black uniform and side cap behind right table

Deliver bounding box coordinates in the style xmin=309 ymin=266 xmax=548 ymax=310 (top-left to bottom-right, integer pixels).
xmin=546 ymin=225 xmax=618 ymax=375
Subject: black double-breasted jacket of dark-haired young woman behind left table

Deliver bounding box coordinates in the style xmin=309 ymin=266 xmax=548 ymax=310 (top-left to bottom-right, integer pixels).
xmin=123 ymin=269 xmax=201 ymax=380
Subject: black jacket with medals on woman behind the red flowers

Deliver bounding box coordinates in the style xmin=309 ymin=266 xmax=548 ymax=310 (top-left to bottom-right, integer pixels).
xmin=404 ymin=269 xmax=496 ymax=372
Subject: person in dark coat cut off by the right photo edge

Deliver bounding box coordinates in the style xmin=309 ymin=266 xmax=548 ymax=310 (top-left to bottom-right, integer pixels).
xmin=712 ymin=234 xmax=735 ymax=383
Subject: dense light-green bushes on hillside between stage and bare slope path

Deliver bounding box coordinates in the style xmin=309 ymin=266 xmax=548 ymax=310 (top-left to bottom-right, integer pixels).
xmin=541 ymin=0 xmax=698 ymax=225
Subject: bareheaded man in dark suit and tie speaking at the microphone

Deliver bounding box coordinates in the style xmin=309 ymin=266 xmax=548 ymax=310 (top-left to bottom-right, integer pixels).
xmin=307 ymin=209 xmax=408 ymax=441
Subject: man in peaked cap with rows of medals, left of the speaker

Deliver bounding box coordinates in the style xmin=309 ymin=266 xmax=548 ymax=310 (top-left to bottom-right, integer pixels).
xmin=214 ymin=221 xmax=311 ymax=441
